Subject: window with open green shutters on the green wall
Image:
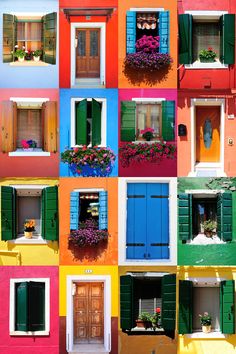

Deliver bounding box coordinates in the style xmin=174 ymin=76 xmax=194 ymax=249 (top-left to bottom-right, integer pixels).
xmin=179 ymin=191 xmax=232 ymax=244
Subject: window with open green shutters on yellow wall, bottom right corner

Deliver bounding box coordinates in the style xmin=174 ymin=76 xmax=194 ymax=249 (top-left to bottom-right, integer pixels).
xmin=179 ymin=278 xmax=235 ymax=334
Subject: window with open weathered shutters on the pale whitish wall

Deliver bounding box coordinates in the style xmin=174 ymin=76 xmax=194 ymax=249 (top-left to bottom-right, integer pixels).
xmin=3 ymin=12 xmax=57 ymax=64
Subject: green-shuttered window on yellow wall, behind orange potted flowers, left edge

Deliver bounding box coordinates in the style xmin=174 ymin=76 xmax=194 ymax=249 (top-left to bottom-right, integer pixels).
xmin=1 ymin=185 xmax=58 ymax=243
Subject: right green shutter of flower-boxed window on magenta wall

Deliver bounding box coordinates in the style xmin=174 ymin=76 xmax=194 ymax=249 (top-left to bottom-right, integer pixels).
xmin=162 ymin=101 xmax=175 ymax=141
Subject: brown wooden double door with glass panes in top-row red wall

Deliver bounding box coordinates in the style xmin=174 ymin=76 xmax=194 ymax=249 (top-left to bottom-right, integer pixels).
xmin=76 ymin=28 xmax=100 ymax=78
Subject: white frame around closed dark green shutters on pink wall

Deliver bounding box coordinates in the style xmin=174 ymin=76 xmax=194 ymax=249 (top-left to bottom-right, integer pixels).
xmin=9 ymin=278 xmax=50 ymax=336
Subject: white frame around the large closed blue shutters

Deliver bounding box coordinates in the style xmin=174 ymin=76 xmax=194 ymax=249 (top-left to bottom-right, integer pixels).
xmin=118 ymin=177 xmax=177 ymax=266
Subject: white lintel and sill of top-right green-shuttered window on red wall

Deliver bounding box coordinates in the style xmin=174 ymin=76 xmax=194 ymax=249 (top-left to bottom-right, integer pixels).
xmin=184 ymin=10 xmax=229 ymax=69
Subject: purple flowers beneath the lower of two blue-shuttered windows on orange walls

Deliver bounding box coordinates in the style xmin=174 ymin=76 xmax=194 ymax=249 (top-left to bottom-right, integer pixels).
xmin=69 ymin=219 xmax=109 ymax=247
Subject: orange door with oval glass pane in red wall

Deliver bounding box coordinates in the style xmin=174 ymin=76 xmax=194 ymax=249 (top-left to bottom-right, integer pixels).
xmin=196 ymin=106 xmax=220 ymax=162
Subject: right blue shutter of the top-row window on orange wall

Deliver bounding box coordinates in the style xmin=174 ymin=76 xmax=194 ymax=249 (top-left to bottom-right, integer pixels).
xmin=159 ymin=11 xmax=170 ymax=53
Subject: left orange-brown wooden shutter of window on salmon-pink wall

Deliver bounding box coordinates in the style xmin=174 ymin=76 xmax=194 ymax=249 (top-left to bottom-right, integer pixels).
xmin=1 ymin=101 xmax=17 ymax=152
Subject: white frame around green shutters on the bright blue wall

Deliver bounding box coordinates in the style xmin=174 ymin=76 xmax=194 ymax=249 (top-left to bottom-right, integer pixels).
xmin=70 ymin=97 xmax=107 ymax=147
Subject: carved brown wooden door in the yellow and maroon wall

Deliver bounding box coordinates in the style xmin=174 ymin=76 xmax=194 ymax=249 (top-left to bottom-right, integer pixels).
xmin=74 ymin=283 xmax=104 ymax=344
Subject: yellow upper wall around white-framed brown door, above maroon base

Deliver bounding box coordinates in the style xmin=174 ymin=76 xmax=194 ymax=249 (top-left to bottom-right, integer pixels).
xmin=59 ymin=266 xmax=118 ymax=317
